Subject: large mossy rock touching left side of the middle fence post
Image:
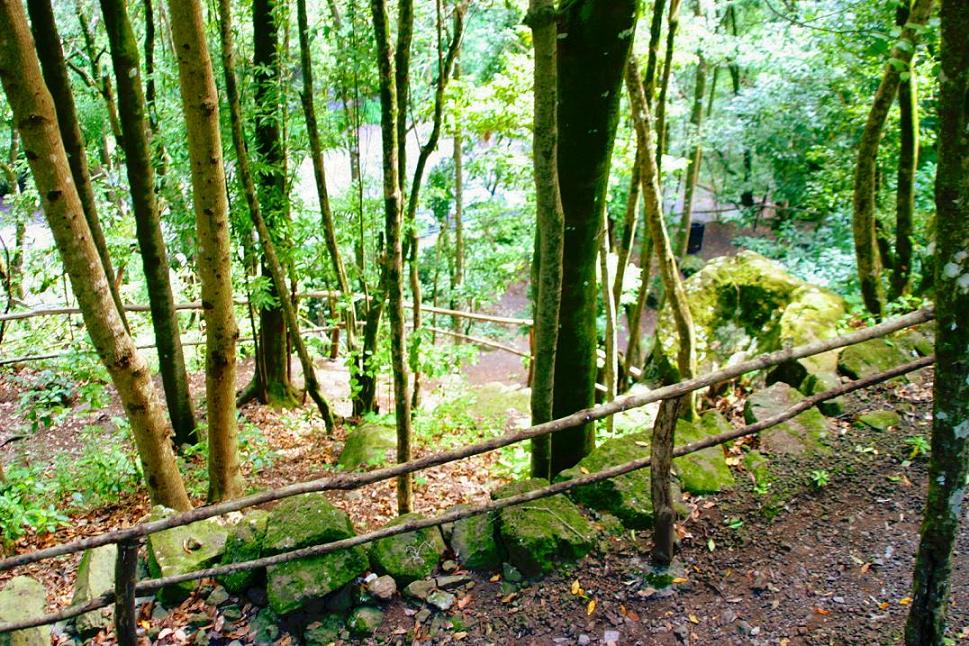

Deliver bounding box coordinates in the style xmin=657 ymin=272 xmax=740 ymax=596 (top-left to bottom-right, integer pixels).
xmin=555 ymin=432 xmax=685 ymax=529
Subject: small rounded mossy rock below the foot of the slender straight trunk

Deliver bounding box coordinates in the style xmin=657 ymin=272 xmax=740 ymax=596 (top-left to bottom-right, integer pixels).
xmin=370 ymin=514 xmax=447 ymax=585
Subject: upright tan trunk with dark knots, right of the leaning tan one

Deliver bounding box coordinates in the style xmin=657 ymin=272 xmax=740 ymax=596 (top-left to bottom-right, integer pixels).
xmin=168 ymin=0 xmax=244 ymax=502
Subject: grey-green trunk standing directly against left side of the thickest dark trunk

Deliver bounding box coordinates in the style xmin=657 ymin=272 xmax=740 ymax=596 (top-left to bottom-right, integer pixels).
xmin=524 ymin=0 xmax=565 ymax=479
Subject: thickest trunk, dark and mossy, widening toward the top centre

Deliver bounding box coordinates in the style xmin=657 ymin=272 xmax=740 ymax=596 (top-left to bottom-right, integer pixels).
xmin=551 ymin=0 xmax=638 ymax=475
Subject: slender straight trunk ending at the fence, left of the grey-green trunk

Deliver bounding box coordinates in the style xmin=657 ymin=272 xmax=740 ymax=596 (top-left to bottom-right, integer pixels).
xmin=370 ymin=0 xmax=413 ymax=514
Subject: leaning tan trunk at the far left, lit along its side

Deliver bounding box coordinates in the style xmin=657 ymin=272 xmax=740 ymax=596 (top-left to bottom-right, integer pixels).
xmin=0 ymin=1 xmax=191 ymax=510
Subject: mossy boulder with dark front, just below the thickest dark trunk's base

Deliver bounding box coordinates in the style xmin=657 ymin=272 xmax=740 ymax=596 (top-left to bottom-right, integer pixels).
xmin=491 ymin=478 xmax=595 ymax=576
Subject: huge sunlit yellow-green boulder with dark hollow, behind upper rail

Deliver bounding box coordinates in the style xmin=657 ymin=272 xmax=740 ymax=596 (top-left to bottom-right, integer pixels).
xmin=650 ymin=251 xmax=845 ymax=387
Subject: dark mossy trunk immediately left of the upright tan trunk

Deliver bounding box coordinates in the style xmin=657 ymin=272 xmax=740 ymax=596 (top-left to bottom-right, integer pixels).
xmin=101 ymin=0 xmax=198 ymax=446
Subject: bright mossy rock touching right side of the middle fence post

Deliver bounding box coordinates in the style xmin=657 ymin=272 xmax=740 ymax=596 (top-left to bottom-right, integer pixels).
xmin=673 ymin=411 xmax=734 ymax=494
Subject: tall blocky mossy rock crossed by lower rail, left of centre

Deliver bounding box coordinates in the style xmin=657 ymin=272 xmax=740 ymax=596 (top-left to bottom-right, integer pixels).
xmin=262 ymin=493 xmax=370 ymax=615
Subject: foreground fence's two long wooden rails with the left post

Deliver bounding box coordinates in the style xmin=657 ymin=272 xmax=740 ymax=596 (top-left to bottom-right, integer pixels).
xmin=0 ymin=308 xmax=934 ymax=646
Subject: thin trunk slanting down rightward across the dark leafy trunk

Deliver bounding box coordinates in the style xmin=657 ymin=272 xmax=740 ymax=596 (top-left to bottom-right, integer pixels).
xmin=219 ymin=0 xmax=334 ymax=433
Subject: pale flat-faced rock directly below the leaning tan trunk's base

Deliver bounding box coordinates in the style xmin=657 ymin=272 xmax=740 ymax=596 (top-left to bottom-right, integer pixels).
xmin=148 ymin=506 xmax=229 ymax=607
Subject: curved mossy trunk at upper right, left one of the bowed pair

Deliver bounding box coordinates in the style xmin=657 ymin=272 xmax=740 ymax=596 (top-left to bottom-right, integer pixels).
xmin=851 ymin=0 xmax=932 ymax=317
